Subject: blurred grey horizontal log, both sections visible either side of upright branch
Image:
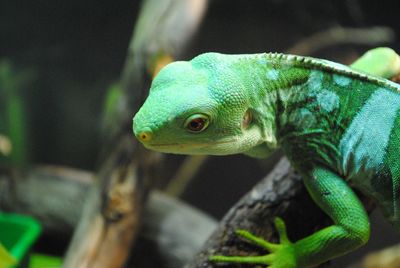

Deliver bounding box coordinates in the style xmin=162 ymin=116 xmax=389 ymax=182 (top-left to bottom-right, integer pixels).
xmin=0 ymin=166 xmax=217 ymax=268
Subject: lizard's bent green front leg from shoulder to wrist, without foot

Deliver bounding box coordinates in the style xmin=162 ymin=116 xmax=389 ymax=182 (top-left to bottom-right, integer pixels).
xmin=295 ymin=168 xmax=370 ymax=267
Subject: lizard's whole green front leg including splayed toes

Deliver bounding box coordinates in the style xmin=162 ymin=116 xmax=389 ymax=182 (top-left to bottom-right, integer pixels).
xmin=211 ymin=168 xmax=370 ymax=268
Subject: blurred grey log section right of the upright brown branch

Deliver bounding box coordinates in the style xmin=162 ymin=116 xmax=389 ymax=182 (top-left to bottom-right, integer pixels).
xmin=128 ymin=192 xmax=217 ymax=268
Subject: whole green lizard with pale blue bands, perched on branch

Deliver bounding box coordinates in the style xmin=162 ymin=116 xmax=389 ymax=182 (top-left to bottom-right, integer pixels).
xmin=133 ymin=49 xmax=400 ymax=268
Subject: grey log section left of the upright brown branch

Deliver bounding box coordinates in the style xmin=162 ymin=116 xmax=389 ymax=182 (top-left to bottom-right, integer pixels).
xmin=0 ymin=165 xmax=93 ymax=233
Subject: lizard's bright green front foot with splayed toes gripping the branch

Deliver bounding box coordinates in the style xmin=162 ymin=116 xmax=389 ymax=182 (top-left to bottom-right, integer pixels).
xmin=209 ymin=217 xmax=296 ymax=268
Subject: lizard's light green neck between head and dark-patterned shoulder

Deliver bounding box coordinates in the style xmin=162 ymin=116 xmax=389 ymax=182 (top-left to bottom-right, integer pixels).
xmin=227 ymin=53 xmax=311 ymax=157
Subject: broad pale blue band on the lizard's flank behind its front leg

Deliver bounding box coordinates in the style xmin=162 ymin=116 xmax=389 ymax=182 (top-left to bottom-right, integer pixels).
xmin=339 ymin=88 xmax=400 ymax=181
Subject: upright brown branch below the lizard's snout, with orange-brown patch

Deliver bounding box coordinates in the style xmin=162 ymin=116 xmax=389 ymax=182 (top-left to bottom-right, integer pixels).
xmin=63 ymin=136 xmax=155 ymax=267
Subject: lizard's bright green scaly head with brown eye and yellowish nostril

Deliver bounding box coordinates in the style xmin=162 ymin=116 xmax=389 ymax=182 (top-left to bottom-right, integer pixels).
xmin=133 ymin=53 xmax=268 ymax=155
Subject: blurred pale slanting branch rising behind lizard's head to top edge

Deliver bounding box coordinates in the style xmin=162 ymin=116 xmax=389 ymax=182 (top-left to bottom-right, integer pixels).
xmin=103 ymin=0 xmax=208 ymax=147
